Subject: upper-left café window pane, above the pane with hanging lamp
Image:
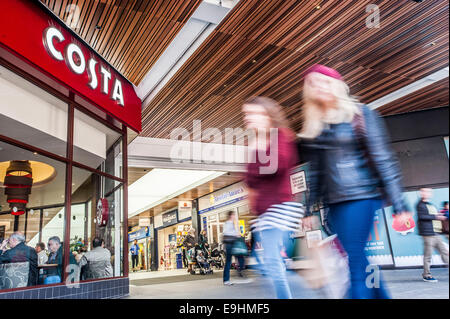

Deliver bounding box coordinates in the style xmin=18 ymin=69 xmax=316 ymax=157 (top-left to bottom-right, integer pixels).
xmin=0 ymin=66 xmax=68 ymax=157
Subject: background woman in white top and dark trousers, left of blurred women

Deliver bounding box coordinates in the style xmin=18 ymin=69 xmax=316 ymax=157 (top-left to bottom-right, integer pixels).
xmin=223 ymin=210 xmax=245 ymax=286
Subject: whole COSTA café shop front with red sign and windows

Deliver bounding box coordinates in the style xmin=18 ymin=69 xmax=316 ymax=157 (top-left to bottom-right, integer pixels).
xmin=0 ymin=0 xmax=141 ymax=298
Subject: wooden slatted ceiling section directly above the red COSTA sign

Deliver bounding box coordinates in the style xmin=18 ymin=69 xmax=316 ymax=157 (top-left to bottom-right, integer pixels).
xmin=40 ymin=0 xmax=202 ymax=85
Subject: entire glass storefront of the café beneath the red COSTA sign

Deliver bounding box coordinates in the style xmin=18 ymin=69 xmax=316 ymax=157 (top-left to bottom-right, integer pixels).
xmin=0 ymin=61 xmax=126 ymax=290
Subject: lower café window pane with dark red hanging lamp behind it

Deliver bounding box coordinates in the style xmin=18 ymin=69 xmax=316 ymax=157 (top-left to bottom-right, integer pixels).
xmin=0 ymin=141 xmax=66 ymax=289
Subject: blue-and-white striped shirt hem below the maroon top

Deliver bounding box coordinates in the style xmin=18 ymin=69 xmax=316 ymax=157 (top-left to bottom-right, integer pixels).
xmin=250 ymin=202 xmax=305 ymax=232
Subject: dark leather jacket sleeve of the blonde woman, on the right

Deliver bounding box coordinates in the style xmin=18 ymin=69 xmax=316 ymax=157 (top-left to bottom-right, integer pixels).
xmin=362 ymin=106 xmax=408 ymax=214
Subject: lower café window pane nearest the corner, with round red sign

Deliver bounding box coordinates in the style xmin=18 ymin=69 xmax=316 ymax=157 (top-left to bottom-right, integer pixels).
xmin=70 ymin=167 xmax=123 ymax=279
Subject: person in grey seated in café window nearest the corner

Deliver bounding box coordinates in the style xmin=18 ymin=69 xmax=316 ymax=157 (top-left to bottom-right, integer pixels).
xmin=79 ymin=237 xmax=113 ymax=279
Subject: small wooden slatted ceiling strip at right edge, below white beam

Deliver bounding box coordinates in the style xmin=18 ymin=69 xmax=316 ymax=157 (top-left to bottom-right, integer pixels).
xmin=378 ymin=78 xmax=449 ymax=116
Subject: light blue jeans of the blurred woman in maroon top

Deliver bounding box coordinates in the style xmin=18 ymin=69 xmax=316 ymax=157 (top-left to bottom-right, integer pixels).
xmin=261 ymin=228 xmax=292 ymax=299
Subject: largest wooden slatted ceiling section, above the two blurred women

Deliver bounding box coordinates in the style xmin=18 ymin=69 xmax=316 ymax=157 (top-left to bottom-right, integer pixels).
xmin=141 ymin=0 xmax=449 ymax=142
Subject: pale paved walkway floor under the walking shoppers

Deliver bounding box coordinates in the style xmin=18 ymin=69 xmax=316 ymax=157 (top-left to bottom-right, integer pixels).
xmin=129 ymin=268 xmax=449 ymax=299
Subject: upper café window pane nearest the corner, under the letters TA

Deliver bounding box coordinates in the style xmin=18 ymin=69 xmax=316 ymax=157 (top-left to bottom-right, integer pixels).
xmin=73 ymin=110 xmax=122 ymax=180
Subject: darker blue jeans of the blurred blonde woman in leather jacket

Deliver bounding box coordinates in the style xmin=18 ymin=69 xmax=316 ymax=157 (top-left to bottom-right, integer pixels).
xmin=328 ymin=199 xmax=390 ymax=299
